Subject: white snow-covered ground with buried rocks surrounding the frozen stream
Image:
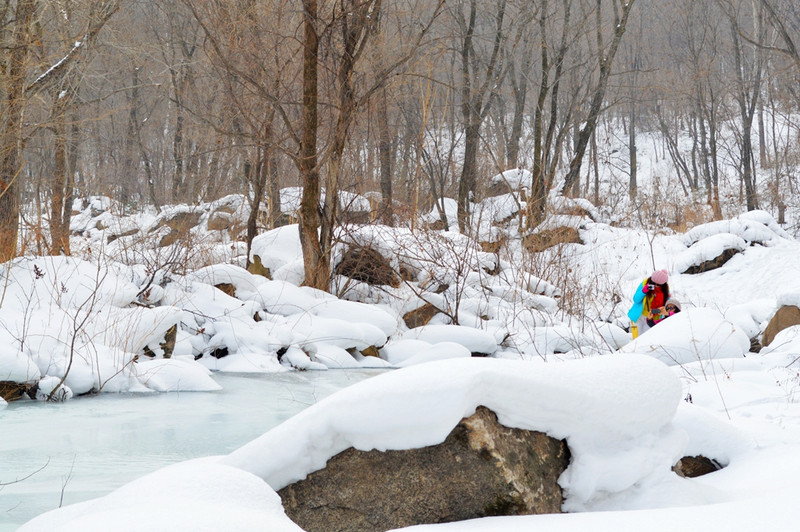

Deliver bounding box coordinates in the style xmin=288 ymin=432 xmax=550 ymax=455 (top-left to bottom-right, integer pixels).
xmin=0 ymin=187 xmax=800 ymax=530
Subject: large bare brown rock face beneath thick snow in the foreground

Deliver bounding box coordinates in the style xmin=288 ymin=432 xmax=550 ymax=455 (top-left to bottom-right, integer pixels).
xmin=278 ymin=407 xmax=569 ymax=532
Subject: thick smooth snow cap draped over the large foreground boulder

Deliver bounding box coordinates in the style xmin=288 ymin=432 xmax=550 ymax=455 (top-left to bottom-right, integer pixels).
xmin=222 ymin=355 xmax=685 ymax=510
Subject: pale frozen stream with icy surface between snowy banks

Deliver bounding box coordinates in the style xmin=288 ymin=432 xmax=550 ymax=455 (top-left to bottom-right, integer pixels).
xmin=0 ymin=370 xmax=382 ymax=532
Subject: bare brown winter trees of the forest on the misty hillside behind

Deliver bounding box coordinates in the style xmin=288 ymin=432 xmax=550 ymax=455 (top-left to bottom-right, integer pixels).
xmin=0 ymin=0 xmax=800 ymax=289
